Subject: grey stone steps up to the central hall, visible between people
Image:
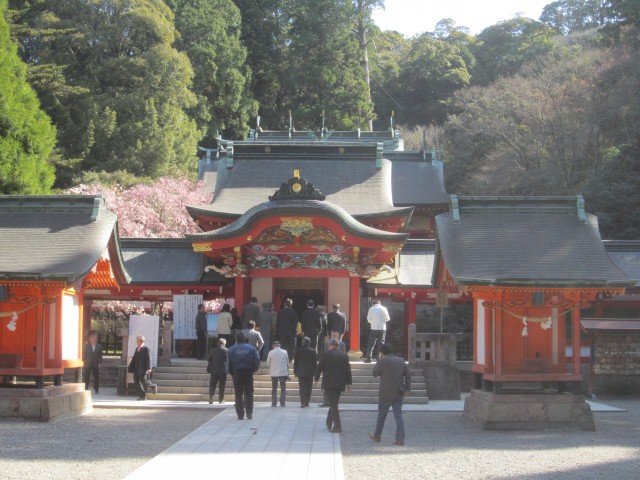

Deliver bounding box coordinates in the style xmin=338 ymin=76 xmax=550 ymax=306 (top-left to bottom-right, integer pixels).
xmin=149 ymin=358 xmax=429 ymax=404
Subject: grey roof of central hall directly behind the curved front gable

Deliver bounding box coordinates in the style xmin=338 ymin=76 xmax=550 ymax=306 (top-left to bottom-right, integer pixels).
xmin=194 ymin=142 xmax=402 ymax=217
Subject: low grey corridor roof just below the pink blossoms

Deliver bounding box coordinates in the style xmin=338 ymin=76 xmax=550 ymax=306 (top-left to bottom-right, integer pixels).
xmin=120 ymin=238 xmax=228 ymax=285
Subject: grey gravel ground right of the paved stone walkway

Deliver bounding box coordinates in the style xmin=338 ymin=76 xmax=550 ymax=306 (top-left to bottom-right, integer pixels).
xmin=340 ymin=398 xmax=640 ymax=480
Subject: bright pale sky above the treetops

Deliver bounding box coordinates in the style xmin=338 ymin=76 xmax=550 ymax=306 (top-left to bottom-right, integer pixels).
xmin=373 ymin=0 xmax=553 ymax=37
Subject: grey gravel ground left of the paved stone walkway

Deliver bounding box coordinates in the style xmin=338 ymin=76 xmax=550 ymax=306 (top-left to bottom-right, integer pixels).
xmin=0 ymin=408 xmax=220 ymax=480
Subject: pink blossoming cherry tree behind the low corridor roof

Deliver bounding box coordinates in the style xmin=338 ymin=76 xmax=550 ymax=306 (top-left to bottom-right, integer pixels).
xmin=66 ymin=177 xmax=211 ymax=238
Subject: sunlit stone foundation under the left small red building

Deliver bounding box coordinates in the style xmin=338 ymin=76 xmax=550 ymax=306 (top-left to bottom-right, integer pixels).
xmin=0 ymin=383 xmax=93 ymax=422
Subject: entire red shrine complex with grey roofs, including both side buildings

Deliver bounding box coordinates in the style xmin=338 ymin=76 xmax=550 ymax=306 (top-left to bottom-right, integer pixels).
xmin=0 ymin=129 xmax=640 ymax=428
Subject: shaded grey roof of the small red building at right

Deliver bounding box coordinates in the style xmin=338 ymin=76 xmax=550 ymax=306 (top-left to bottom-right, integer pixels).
xmin=436 ymin=196 xmax=635 ymax=287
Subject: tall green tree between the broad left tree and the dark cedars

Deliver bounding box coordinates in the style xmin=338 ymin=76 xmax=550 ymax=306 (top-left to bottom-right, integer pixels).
xmin=167 ymin=0 xmax=257 ymax=142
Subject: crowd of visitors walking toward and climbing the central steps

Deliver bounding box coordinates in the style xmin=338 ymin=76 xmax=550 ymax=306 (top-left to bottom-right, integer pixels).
xmin=198 ymin=297 xmax=411 ymax=445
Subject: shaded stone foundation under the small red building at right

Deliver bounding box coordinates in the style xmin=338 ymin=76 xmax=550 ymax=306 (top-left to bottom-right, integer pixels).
xmin=464 ymin=390 xmax=595 ymax=431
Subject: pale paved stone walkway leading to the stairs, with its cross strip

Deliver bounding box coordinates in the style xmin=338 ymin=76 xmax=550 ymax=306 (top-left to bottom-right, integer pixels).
xmin=87 ymin=389 xmax=620 ymax=480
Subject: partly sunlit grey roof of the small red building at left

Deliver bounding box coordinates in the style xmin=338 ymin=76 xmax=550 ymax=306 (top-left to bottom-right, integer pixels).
xmin=0 ymin=195 xmax=129 ymax=284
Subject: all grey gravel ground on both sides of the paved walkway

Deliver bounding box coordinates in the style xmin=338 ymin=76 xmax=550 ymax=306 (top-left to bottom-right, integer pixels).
xmin=0 ymin=398 xmax=640 ymax=480
